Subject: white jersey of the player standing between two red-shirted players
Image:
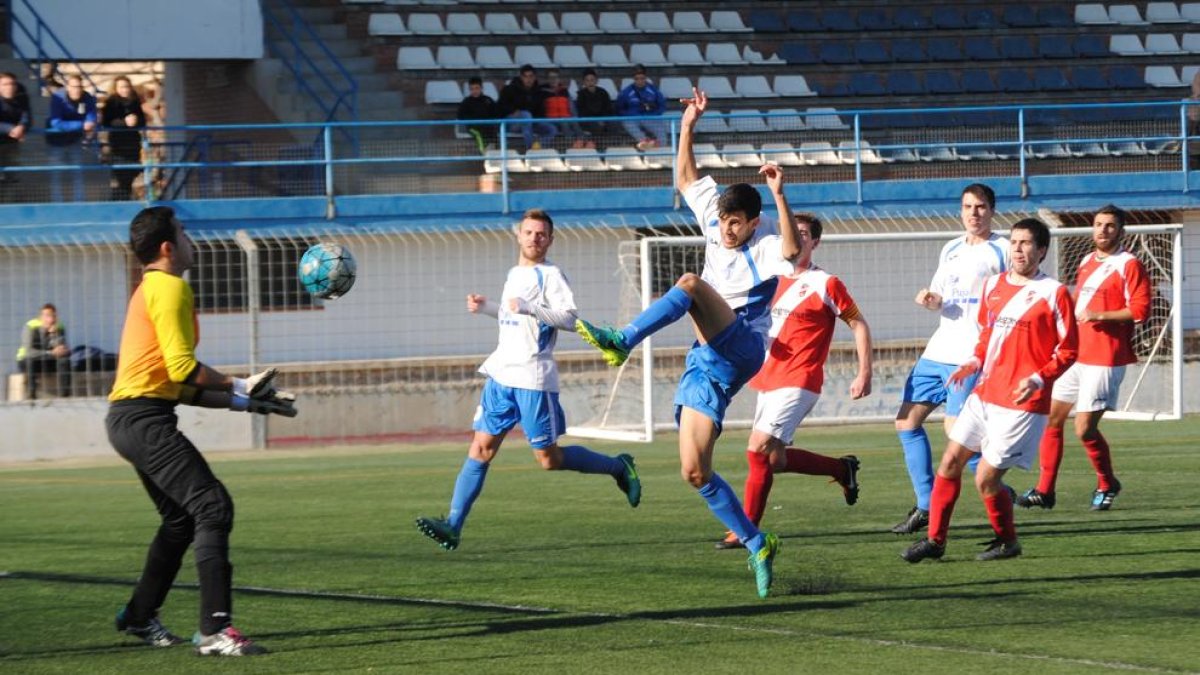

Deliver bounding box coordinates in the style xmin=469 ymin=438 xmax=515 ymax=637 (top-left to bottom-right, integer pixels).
xmin=922 ymin=233 xmax=1009 ymax=365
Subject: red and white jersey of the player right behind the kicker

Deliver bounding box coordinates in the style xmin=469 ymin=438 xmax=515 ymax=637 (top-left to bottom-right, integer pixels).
xmin=750 ymin=265 xmax=858 ymax=394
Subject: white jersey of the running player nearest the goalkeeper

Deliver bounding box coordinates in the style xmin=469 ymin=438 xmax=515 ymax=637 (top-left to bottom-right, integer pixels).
xmin=479 ymin=262 xmax=577 ymax=392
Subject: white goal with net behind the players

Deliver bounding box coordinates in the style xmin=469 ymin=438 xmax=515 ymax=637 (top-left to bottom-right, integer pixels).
xmin=568 ymin=225 xmax=1183 ymax=442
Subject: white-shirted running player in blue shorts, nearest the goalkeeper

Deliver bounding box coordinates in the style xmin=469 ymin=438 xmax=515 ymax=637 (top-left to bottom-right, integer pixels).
xmin=416 ymin=209 xmax=642 ymax=550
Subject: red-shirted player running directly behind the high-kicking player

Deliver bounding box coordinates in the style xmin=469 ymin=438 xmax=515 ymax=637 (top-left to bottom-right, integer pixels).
xmin=716 ymin=214 xmax=871 ymax=549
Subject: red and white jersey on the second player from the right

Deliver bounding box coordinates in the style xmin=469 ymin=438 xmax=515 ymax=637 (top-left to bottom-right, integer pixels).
xmin=974 ymin=273 xmax=1079 ymax=414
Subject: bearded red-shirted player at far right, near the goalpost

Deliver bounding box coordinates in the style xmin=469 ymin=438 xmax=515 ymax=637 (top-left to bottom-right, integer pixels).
xmin=1016 ymin=204 xmax=1150 ymax=510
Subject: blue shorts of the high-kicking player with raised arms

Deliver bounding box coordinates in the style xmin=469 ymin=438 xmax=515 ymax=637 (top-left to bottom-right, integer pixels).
xmin=674 ymin=316 xmax=767 ymax=431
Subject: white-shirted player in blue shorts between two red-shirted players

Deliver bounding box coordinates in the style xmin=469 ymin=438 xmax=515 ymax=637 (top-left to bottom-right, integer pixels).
xmin=892 ymin=183 xmax=1008 ymax=534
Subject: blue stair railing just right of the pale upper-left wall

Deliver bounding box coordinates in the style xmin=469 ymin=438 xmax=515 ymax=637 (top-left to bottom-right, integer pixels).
xmin=262 ymin=0 xmax=359 ymax=148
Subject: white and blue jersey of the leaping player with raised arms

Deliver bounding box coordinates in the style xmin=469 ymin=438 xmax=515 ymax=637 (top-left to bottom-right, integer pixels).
xmin=683 ymin=175 xmax=792 ymax=340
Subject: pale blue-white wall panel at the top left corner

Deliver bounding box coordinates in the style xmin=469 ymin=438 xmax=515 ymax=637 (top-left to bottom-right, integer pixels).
xmin=12 ymin=0 xmax=263 ymax=61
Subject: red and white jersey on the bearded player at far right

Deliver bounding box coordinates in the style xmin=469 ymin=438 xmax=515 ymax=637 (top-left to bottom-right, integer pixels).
xmin=1075 ymin=249 xmax=1150 ymax=365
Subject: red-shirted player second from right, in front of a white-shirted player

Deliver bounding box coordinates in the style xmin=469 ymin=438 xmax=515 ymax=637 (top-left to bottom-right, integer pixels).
xmin=901 ymin=219 xmax=1079 ymax=562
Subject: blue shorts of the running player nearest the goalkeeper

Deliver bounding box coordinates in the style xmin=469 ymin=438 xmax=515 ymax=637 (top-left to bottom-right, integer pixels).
xmin=472 ymin=377 xmax=566 ymax=450
